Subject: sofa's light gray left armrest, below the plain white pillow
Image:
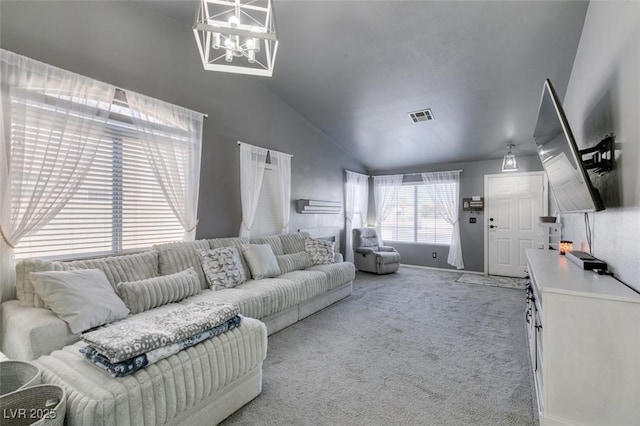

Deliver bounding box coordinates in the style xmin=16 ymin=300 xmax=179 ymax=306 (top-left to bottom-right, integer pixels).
xmin=0 ymin=300 xmax=80 ymax=361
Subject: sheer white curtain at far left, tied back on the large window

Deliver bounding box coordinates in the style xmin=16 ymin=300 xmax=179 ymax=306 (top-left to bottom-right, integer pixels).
xmin=0 ymin=50 xmax=115 ymax=300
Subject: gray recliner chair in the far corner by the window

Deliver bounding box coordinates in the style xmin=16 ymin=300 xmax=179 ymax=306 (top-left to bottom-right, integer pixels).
xmin=353 ymin=228 xmax=400 ymax=274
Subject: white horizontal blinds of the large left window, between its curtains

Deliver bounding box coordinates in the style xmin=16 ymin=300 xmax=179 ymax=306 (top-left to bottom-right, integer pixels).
xmin=11 ymin=99 xmax=187 ymax=258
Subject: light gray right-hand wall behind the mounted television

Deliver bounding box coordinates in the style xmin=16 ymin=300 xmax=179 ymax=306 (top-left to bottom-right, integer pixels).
xmin=562 ymin=1 xmax=640 ymax=290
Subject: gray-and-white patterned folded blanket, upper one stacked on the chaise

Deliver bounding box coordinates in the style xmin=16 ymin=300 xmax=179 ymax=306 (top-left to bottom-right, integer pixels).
xmin=82 ymin=302 xmax=239 ymax=363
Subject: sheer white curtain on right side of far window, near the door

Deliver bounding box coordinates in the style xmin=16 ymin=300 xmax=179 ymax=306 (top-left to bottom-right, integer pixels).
xmin=422 ymin=171 xmax=464 ymax=269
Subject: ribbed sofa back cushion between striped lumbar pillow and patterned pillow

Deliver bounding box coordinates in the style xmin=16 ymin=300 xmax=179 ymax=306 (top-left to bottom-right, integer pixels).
xmin=153 ymin=240 xmax=209 ymax=289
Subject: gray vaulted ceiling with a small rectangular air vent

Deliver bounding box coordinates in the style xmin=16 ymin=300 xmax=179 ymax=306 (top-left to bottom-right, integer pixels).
xmin=138 ymin=0 xmax=588 ymax=171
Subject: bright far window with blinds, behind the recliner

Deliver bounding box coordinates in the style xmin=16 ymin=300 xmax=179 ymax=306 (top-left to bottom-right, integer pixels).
xmin=382 ymin=181 xmax=456 ymax=245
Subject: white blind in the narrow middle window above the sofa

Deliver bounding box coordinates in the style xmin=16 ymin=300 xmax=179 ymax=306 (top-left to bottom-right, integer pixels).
xmin=251 ymin=164 xmax=282 ymax=237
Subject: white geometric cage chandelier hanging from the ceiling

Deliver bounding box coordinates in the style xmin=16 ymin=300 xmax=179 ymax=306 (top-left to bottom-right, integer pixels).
xmin=193 ymin=0 xmax=278 ymax=77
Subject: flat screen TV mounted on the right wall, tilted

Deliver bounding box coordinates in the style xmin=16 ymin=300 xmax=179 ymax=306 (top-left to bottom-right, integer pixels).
xmin=533 ymin=80 xmax=604 ymax=213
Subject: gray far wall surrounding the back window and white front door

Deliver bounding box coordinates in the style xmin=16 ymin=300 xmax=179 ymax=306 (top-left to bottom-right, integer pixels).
xmin=369 ymin=155 xmax=542 ymax=272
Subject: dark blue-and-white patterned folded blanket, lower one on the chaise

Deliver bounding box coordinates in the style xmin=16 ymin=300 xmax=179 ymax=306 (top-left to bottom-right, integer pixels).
xmin=80 ymin=315 xmax=241 ymax=377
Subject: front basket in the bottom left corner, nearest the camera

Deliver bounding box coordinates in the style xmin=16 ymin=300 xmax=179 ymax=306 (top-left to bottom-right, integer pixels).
xmin=0 ymin=385 xmax=67 ymax=426
